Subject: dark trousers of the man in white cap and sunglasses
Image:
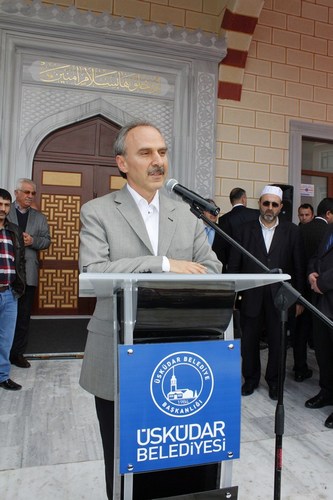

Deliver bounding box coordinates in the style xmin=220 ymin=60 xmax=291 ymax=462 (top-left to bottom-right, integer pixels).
xmin=241 ymin=287 xmax=281 ymax=386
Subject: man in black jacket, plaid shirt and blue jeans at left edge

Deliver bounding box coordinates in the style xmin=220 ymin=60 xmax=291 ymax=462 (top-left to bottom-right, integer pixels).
xmin=0 ymin=189 xmax=25 ymax=391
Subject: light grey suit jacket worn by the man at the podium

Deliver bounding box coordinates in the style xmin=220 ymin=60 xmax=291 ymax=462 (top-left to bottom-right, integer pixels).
xmin=79 ymin=186 xmax=222 ymax=400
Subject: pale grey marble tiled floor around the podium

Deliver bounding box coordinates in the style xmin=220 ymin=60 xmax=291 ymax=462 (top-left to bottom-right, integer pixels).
xmin=0 ymin=350 xmax=333 ymax=500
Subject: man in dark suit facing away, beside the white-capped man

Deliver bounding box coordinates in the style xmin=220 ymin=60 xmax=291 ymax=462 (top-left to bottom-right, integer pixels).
xmin=218 ymin=187 xmax=259 ymax=273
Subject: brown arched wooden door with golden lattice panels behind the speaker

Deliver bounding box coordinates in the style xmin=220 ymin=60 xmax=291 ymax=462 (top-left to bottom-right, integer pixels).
xmin=33 ymin=116 xmax=124 ymax=316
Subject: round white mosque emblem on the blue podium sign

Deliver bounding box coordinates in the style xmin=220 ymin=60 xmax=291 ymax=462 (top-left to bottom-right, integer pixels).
xmin=150 ymin=351 xmax=214 ymax=418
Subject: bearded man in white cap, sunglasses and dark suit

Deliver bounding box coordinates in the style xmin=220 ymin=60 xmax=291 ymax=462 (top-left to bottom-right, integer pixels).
xmin=228 ymin=186 xmax=305 ymax=400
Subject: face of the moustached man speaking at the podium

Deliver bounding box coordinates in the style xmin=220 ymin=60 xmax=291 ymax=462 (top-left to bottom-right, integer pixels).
xmin=116 ymin=126 xmax=168 ymax=202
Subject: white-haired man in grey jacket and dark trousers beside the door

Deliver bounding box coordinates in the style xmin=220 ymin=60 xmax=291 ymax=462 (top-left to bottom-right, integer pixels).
xmin=8 ymin=179 xmax=51 ymax=368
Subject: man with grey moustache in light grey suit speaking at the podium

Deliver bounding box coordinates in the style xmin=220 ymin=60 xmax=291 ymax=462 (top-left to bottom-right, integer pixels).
xmin=79 ymin=121 xmax=222 ymax=500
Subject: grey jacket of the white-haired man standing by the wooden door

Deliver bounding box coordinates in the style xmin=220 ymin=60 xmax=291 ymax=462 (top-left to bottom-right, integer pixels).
xmin=8 ymin=203 xmax=51 ymax=286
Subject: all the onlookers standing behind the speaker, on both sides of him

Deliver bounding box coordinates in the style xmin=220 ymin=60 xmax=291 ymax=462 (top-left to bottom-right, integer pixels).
xmin=0 ymin=173 xmax=333 ymax=428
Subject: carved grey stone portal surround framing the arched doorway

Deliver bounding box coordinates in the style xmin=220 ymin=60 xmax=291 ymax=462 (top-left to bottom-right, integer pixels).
xmin=0 ymin=0 xmax=226 ymax=196
